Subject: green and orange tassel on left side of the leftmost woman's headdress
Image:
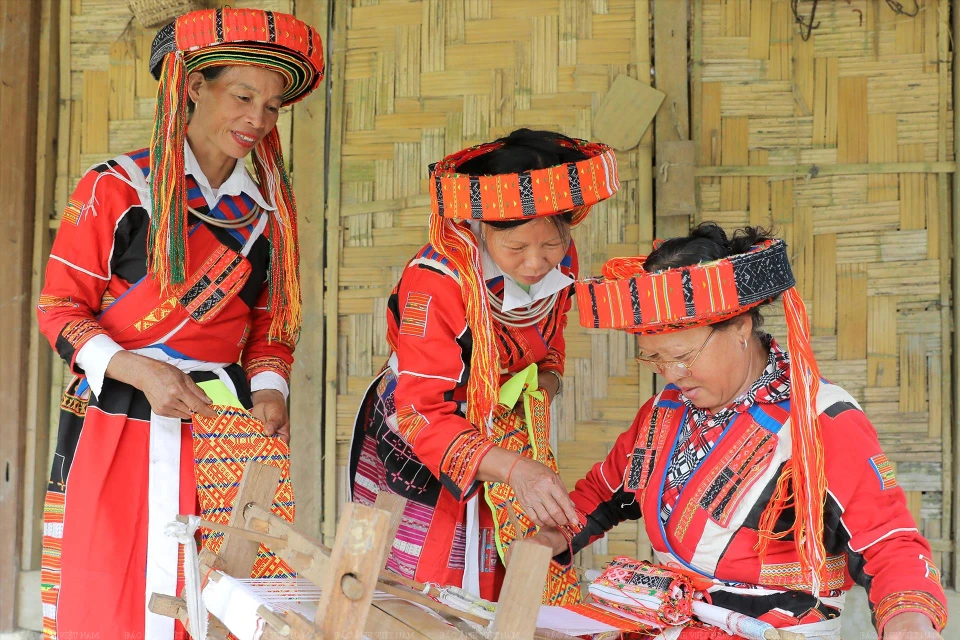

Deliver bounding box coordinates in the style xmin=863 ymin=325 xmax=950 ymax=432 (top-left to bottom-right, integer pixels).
xmin=147 ymin=52 xmax=189 ymax=292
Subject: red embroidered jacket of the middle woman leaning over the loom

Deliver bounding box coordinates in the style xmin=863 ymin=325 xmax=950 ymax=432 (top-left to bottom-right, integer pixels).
xmin=387 ymin=242 xmax=578 ymax=500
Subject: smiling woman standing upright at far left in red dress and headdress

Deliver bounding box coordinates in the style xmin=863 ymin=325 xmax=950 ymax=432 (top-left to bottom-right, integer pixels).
xmin=38 ymin=9 xmax=323 ymax=640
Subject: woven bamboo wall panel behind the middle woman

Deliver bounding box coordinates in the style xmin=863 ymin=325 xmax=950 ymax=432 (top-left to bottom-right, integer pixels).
xmin=327 ymin=0 xmax=652 ymax=564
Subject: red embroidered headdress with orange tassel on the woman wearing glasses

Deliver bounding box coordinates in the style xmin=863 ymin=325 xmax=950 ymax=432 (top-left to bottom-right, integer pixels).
xmin=576 ymin=239 xmax=826 ymax=593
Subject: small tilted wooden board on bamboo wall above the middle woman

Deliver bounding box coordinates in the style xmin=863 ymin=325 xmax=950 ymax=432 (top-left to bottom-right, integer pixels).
xmin=593 ymin=73 xmax=665 ymax=151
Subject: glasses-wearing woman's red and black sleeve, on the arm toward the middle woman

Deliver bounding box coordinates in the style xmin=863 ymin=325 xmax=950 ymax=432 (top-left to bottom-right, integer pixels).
xmin=570 ymin=398 xmax=653 ymax=553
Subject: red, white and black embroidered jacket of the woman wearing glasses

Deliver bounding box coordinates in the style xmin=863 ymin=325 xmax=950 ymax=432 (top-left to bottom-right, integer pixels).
xmin=571 ymin=382 xmax=946 ymax=630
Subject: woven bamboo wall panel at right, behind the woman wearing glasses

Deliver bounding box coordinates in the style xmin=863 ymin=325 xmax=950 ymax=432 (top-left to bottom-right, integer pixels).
xmin=693 ymin=0 xmax=956 ymax=570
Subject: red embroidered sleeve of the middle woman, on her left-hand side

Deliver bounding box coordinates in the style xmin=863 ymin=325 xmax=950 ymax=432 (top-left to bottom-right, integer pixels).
xmin=394 ymin=266 xmax=496 ymax=500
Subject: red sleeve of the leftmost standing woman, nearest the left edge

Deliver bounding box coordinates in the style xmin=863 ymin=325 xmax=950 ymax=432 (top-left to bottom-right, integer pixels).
xmin=37 ymin=165 xmax=133 ymax=374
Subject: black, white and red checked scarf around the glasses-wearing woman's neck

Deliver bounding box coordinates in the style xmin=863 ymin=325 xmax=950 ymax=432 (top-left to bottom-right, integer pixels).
xmin=660 ymin=335 xmax=790 ymax=523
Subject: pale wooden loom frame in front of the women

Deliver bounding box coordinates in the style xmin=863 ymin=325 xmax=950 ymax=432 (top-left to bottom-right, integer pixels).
xmin=149 ymin=462 xmax=569 ymax=640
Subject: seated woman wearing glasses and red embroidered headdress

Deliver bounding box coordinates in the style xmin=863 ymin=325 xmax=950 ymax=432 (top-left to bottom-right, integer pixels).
xmin=536 ymin=223 xmax=946 ymax=640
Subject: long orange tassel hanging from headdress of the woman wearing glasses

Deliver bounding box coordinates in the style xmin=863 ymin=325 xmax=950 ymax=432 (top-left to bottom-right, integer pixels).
xmin=756 ymin=288 xmax=827 ymax=596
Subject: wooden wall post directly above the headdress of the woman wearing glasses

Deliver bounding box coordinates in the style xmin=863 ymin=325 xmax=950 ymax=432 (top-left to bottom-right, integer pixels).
xmin=653 ymin=0 xmax=693 ymax=238
